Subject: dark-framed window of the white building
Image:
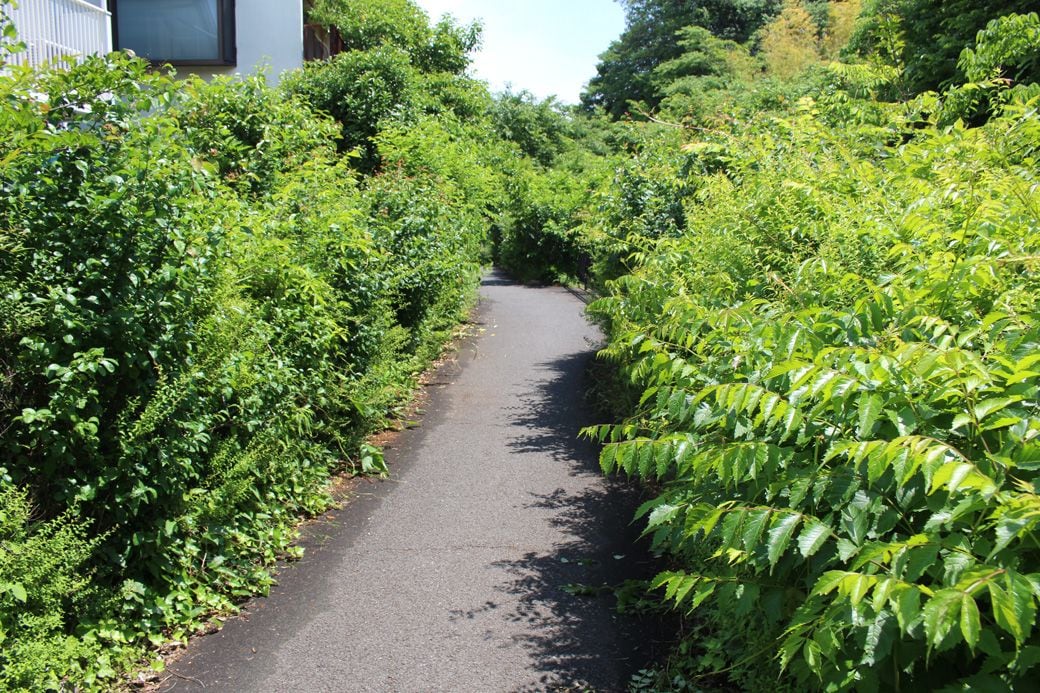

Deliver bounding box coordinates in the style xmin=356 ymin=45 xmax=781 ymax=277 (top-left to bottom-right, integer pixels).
xmin=112 ymin=0 xmax=235 ymax=65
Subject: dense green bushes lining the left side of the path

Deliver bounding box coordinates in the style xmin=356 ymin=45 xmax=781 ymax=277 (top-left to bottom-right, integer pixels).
xmin=0 ymin=6 xmax=497 ymax=678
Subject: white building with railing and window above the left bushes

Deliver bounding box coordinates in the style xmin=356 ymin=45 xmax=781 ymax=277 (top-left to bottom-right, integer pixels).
xmin=2 ymin=0 xmax=304 ymax=81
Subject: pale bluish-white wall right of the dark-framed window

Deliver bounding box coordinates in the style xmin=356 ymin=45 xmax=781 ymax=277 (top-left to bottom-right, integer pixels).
xmin=188 ymin=0 xmax=304 ymax=83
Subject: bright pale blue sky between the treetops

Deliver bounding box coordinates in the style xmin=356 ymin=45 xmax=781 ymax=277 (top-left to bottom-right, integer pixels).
xmin=415 ymin=0 xmax=625 ymax=103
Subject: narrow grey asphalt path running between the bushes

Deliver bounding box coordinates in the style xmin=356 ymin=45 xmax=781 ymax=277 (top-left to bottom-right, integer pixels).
xmin=163 ymin=273 xmax=647 ymax=692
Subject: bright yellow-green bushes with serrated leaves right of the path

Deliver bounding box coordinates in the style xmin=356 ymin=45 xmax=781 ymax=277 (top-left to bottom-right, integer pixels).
xmin=565 ymin=10 xmax=1040 ymax=690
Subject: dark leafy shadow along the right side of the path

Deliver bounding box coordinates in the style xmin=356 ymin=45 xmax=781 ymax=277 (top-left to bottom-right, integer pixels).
xmin=494 ymin=351 xmax=660 ymax=691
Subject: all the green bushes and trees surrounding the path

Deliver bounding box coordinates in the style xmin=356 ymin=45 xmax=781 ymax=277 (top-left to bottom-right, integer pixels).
xmin=0 ymin=0 xmax=1040 ymax=690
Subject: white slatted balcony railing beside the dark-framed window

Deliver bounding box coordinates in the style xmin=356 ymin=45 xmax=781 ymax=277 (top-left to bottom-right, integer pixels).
xmin=7 ymin=0 xmax=112 ymax=66
